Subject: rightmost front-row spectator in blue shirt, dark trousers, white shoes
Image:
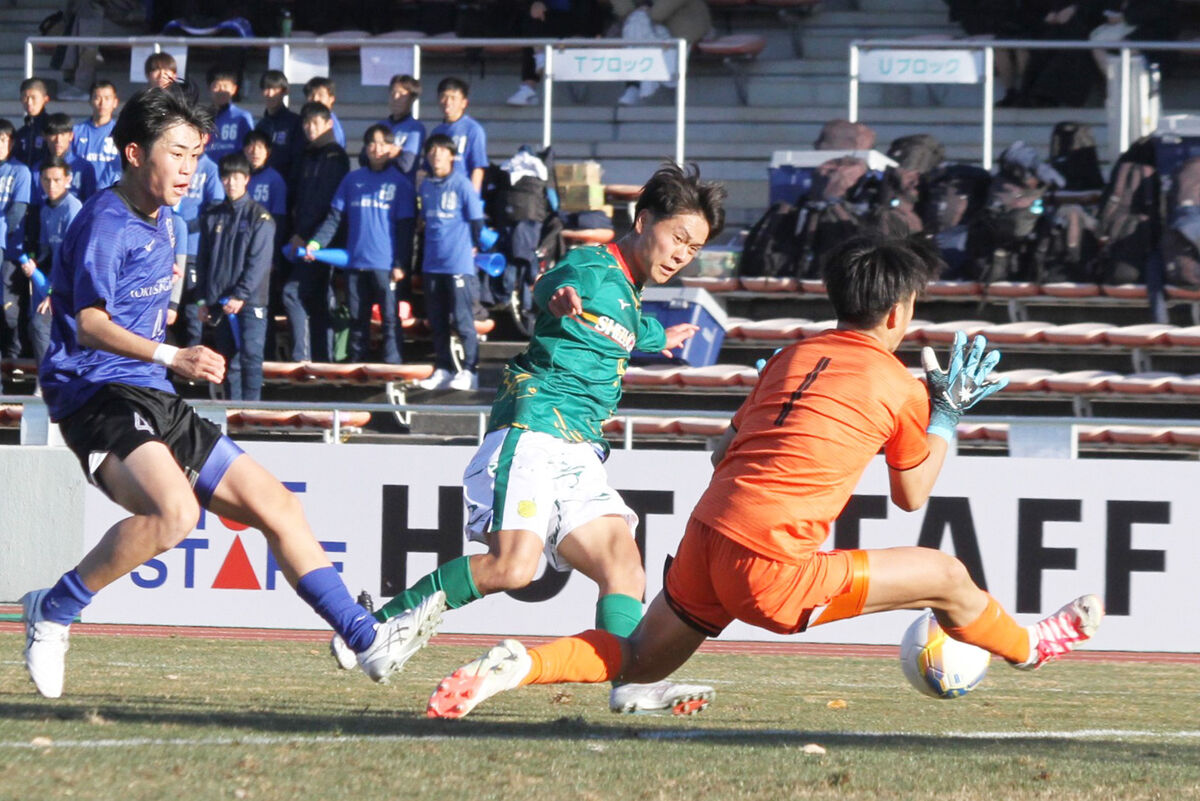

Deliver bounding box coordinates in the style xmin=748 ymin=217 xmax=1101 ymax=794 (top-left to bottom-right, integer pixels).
xmin=420 ymin=133 xmax=484 ymax=390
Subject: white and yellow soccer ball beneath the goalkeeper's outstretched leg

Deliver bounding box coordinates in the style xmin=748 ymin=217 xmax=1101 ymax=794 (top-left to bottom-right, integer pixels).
xmin=900 ymin=612 xmax=991 ymax=698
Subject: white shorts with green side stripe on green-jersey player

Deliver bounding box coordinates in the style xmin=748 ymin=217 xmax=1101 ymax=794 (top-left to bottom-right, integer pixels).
xmin=462 ymin=428 xmax=637 ymax=571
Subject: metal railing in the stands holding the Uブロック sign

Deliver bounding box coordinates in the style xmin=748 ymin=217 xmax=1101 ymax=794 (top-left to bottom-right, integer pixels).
xmin=848 ymin=38 xmax=1200 ymax=168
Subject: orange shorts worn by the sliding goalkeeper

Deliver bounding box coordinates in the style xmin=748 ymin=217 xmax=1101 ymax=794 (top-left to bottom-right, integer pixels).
xmin=662 ymin=518 xmax=868 ymax=637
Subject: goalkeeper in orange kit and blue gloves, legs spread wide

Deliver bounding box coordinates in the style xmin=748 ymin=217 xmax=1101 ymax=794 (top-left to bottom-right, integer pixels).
xmin=428 ymin=235 xmax=1104 ymax=718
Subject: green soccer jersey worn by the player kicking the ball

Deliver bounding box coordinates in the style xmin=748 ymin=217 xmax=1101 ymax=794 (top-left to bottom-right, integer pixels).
xmin=491 ymin=245 xmax=666 ymax=448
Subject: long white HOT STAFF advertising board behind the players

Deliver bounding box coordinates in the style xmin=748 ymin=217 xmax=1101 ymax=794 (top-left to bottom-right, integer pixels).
xmin=84 ymin=442 xmax=1200 ymax=651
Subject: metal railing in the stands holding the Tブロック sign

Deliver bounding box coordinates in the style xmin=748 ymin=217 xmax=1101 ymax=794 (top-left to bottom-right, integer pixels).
xmin=25 ymin=36 xmax=688 ymax=164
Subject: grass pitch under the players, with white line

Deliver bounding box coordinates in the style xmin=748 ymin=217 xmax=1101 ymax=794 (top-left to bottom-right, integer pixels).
xmin=0 ymin=633 xmax=1200 ymax=801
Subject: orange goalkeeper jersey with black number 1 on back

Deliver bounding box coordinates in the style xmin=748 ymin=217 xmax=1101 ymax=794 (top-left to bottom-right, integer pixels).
xmin=692 ymin=330 xmax=929 ymax=564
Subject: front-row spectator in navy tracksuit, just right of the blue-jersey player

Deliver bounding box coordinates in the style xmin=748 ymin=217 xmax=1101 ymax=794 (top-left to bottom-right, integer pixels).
xmin=196 ymin=152 xmax=275 ymax=401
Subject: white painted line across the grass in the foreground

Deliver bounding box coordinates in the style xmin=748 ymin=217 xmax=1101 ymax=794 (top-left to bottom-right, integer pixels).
xmin=0 ymin=729 xmax=1200 ymax=749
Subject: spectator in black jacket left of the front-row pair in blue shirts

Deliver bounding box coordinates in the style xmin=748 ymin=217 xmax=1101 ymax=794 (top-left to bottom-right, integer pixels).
xmin=283 ymin=101 xmax=350 ymax=362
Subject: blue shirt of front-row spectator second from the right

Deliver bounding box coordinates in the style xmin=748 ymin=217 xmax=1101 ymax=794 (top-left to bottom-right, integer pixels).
xmin=330 ymin=165 xmax=420 ymax=270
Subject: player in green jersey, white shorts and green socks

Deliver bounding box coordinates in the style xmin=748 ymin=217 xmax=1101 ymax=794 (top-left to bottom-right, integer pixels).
xmin=334 ymin=164 xmax=725 ymax=713
